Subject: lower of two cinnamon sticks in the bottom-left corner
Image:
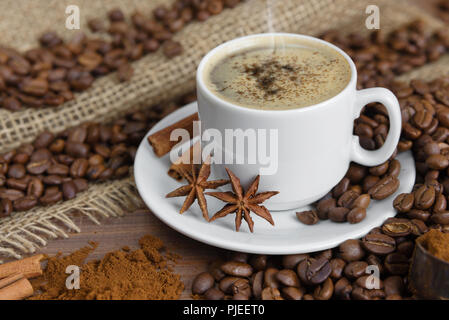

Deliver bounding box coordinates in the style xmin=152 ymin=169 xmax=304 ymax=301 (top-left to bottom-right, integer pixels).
xmin=0 ymin=274 xmax=34 ymax=300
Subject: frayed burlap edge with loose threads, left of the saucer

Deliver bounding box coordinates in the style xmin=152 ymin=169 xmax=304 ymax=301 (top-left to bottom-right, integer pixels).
xmin=0 ymin=177 xmax=143 ymax=261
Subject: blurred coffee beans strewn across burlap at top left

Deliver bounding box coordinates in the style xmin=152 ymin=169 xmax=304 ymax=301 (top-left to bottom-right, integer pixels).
xmin=0 ymin=0 xmax=241 ymax=111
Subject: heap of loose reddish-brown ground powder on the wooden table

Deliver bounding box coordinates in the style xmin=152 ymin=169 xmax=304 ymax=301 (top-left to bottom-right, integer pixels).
xmin=31 ymin=235 xmax=184 ymax=300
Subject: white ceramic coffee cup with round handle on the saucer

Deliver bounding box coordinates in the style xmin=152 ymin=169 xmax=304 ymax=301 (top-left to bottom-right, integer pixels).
xmin=196 ymin=33 xmax=401 ymax=210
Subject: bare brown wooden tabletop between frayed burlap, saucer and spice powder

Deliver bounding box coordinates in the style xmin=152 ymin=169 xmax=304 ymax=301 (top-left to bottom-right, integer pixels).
xmin=34 ymin=0 xmax=436 ymax=299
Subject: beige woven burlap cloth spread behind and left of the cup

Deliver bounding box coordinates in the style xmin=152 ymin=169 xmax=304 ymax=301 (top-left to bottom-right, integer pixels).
xmin=0 ymin=0 xmax=449 ymax=258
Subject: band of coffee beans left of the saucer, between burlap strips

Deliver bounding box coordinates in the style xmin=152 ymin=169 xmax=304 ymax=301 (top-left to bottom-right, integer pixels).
xmin=0 ymin=94 xmax=196 ymax=217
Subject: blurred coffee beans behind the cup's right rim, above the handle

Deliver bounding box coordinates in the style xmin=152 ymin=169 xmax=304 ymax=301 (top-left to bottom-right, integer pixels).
xmin=321 ymin=21 xmax=449 ymax=89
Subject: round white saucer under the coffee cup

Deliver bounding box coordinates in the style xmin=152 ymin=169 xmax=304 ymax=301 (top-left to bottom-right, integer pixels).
xmin=134 ymin=102 xmax=415 ymax=254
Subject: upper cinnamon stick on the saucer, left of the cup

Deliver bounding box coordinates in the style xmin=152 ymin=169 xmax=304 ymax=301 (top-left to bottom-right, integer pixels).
xmin=148 ymin=113 xmax=198 ymax=157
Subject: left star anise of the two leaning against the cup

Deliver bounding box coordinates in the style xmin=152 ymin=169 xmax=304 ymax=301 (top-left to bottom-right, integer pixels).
xmin=165 ymin=157 xmax=229 ymax=221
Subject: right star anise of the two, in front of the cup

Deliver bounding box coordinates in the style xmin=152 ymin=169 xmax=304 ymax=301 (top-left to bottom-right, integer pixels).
xmin=206 ymin=168 xmax=279 ymax=232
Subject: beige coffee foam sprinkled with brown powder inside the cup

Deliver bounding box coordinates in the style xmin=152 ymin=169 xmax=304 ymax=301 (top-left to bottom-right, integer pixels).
xmin=205 ymin=41 xmax=351 ymax=110
